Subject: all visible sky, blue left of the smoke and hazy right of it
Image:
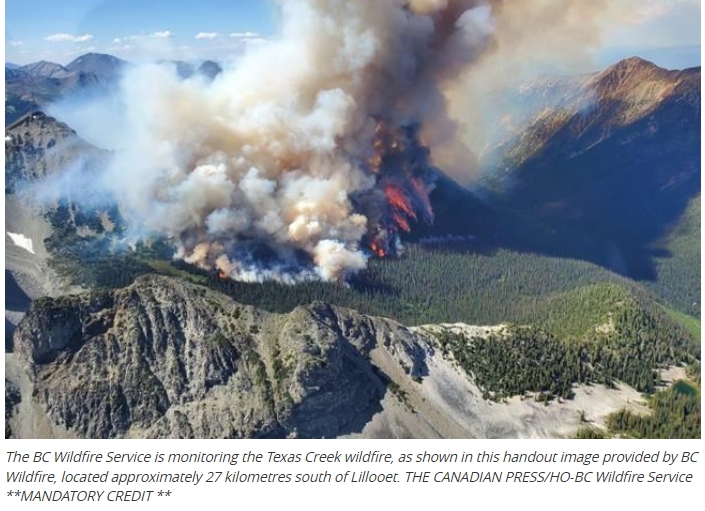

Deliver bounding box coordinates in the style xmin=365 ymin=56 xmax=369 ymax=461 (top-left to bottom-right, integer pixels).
xmin=5 ymin=0 xmax=701 ymax=67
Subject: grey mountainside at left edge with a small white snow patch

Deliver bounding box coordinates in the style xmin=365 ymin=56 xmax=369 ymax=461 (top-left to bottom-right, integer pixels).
xmin=5 ymin=112 xmax=112 ymax=324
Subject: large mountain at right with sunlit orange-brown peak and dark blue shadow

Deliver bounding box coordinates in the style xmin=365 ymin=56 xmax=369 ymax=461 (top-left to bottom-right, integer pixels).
xmin=485 ymin=58 xmax=701 ymax=292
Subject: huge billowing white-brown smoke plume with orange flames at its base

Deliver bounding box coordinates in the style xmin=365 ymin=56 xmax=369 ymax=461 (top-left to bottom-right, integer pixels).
xmin=97 ymin=0 xmax=612 ymax=281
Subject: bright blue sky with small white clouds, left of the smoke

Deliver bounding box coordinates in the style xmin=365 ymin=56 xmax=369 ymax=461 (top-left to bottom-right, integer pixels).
xmin=5 ymin=0 xmax=275 ymax=64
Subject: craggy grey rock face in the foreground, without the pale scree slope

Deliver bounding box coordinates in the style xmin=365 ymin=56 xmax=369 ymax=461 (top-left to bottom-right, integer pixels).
xmin=12 ymin=276 xmax=426 ymax=438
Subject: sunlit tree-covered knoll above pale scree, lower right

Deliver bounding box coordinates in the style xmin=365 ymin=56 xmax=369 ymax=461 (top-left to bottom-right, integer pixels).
xmin=428 ymin=284 xmax=700 ymax=400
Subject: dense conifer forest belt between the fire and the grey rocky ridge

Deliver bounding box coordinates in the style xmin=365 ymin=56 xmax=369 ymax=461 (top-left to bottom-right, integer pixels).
xmin=60 ymin=245 xmax=693 ymax=346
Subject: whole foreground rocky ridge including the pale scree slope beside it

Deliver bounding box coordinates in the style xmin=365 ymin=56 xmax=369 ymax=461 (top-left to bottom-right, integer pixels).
xmin=5 ymin=276 xmax=692 ymax=438
